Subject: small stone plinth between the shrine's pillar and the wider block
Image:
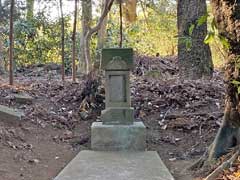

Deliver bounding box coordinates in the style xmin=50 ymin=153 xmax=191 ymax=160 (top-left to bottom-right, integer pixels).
xmin=101 ymin=108 xmax=134 ymax=125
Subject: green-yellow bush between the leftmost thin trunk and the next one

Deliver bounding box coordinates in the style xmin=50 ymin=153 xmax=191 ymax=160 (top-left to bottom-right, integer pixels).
xmin=14 ymin=15 xmax=68 ymax=66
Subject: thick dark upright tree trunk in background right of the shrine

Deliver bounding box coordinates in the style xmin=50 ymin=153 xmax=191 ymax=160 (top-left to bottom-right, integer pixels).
xmin=177 ymin=0 xmax=213 ymax=80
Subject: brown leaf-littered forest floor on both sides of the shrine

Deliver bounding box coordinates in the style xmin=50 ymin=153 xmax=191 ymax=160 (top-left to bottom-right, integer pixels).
xmin=0 ymin=56 xmax=224 ymax=180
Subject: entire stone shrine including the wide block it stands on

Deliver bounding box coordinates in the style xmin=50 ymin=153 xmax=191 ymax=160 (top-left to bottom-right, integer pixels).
xmin=91 ymin=48 xmax=146 ymax=151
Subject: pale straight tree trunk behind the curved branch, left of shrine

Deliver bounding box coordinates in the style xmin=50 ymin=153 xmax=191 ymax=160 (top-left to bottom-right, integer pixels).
xmin=79 ymin=0 xmax=92 ymax=73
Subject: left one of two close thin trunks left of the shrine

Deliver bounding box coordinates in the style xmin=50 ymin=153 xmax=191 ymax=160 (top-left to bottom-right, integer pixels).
xmin=59 ymin=0 xmax=65 ymax=81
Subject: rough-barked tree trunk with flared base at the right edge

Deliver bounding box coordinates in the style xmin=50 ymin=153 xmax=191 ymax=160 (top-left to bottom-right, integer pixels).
xmin=208 ymin=0 xmax=240 ymax=160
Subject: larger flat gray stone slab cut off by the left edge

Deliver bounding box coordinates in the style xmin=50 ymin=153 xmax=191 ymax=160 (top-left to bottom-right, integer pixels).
xmin=0 ymin=105 xmax=24 ymax=122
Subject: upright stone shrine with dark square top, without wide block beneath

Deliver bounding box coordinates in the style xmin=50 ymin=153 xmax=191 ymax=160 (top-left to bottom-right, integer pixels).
xmin=101 ymin=49 xmax=133 ymax=125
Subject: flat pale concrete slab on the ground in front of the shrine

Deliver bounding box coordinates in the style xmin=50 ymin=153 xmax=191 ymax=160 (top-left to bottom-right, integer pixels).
xmin=54 ymin=151 xmax=174 ymax=180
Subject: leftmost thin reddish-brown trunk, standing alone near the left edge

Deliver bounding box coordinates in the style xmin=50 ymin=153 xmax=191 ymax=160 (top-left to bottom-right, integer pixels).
xmin=9 ymin=0 xmax=15 ymax=85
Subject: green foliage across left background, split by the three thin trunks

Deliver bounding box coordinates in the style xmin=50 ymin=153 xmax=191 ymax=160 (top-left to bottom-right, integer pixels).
xmin=0 ymin=10 xmax=75 ymax=66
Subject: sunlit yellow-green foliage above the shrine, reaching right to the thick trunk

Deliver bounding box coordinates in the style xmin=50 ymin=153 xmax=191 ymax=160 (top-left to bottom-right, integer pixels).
xmin=106 ymin=1 xmax=177 ymax=56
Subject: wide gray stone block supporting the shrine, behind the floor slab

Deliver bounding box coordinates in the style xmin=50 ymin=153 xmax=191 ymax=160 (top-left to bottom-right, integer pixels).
xmin=91 ymin=122 xmax=146 ymax=151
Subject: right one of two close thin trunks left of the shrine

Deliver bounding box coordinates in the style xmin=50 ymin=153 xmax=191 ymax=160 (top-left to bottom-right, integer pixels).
xmin=72 ymin=0 xmax=78 ymax=82
